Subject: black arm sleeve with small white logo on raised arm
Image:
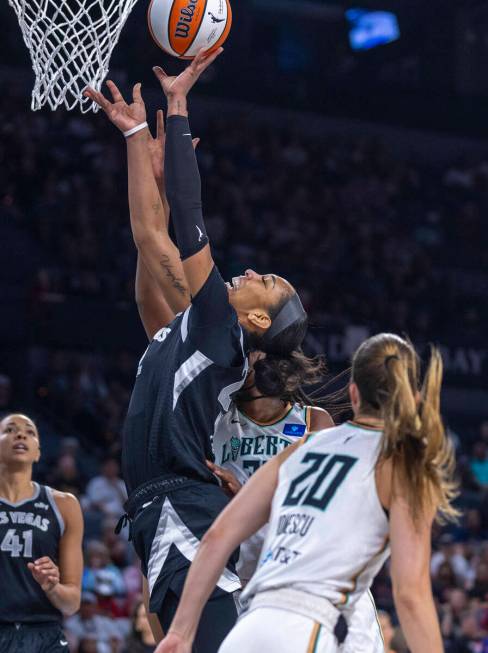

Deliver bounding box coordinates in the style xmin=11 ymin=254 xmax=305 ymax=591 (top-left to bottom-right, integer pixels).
xmin=165 ymin=116 xmax=208 ymax=261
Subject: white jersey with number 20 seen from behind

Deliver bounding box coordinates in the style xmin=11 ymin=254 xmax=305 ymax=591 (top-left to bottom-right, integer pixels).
xmin=243 ymin=422 xmax=389 ymax=609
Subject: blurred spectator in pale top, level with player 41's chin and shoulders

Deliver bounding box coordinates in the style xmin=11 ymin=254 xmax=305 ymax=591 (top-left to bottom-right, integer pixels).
xmin=85 ymin=458 xmax=127 ymax=518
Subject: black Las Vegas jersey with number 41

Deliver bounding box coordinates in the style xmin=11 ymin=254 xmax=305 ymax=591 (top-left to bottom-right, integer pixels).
xmin=0 ymin=483 xmax=64 ymax=623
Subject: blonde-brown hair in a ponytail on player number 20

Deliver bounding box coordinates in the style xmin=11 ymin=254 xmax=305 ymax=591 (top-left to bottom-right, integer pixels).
xmin=353 ymin=334 xmax=458 ymax=522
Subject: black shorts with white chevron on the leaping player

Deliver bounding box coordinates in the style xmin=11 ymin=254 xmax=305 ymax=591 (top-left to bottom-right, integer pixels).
xmin=131 ymin=481 xmax=240 ymax=615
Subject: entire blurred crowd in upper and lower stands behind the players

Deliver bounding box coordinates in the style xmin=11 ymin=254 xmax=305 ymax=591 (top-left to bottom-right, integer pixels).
xmin=0 ymin=88 xmax=488 ymax=653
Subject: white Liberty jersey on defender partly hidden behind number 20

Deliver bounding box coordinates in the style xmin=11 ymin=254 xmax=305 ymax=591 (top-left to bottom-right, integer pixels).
xmin=213 ymin=404 xmax=311 ymax=583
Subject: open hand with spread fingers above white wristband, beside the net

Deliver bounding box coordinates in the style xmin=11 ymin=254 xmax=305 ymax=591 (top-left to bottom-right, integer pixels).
xmin=83 ymin=80 xmax=146 ymax=132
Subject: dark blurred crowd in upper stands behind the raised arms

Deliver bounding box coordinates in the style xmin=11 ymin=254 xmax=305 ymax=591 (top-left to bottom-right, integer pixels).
xmin=0 ymin=84 xmax=488 ymax=340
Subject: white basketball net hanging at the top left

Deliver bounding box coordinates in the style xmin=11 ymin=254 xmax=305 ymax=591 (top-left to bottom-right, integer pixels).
xmin=9 ymin=0 xmax=137 ymax=113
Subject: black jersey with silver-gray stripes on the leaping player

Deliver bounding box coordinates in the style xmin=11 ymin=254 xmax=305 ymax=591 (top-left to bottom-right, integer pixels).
xmin=122 ymin=267 xmax=248 ymax=494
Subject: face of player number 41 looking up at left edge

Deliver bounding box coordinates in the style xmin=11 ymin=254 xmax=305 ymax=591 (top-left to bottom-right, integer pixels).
xmin=0 ymin=415 xmax=41 ymax=465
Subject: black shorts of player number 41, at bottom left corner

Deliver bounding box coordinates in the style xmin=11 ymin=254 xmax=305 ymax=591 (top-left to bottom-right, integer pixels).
xmin=0 ymin=623 xmax=69 ymax=653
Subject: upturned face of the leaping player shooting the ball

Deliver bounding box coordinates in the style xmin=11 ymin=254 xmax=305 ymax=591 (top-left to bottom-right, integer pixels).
xmin=227 ymin=270 xmax=294 ymax=324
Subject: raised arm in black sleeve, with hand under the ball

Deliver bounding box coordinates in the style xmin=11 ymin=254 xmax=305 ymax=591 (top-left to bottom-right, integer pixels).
xmin=154 ymin=48 xmax=222 ymax=297
